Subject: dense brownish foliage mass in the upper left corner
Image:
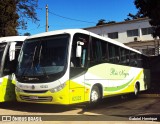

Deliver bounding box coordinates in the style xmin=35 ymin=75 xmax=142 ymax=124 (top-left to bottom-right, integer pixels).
xmin=0 ymin=0 xmax=19 ymax=37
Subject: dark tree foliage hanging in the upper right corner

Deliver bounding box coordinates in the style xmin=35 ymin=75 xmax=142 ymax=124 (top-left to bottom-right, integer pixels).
xmin=134 ymin=0 xmax=160 ymax=37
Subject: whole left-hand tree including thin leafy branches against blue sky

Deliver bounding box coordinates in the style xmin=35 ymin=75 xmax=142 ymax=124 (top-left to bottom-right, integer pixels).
xmin=0 ymin=0 xmax=38 ymax=37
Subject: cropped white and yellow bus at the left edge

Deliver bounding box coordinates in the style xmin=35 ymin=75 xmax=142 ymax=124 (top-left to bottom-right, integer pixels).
xmin=0 ymin=36 xmax=27 ymax=102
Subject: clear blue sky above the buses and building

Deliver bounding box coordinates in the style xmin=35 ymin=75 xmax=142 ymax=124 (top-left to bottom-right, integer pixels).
xmin=18 ymin=0 xmax=137 ymax=35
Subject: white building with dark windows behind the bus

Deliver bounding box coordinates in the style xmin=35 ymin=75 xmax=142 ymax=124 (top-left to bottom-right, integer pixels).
xmin=85 ymin=18 xmax=159 ymax=55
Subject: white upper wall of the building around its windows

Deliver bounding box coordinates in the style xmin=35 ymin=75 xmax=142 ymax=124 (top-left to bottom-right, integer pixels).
xmin=86 ymin=19 xmax=153 ymax=43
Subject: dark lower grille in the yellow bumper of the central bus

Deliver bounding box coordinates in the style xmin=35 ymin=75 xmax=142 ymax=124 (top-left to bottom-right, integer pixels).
xmin=20 ymin=95 xmax=53 ymax=102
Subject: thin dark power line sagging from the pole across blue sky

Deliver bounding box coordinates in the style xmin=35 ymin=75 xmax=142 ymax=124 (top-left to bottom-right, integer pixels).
xmin=48 ymin=11 xmax=96 ymax=24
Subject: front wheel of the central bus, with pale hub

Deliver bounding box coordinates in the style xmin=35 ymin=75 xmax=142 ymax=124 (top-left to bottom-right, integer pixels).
xmin=90 ymin=86 xmax=101 ymax=104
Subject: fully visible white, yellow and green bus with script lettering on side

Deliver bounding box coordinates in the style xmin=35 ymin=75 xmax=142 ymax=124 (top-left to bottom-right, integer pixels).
xmin=15 ymin=29 xmax=150 ymax=104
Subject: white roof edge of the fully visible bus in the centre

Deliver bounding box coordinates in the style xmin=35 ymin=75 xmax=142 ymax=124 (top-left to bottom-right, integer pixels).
xmin=27 ymin=29 xmax=142 ymax=54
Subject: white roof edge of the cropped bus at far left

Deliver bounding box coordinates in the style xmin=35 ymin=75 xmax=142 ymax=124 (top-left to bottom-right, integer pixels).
xmin=0 ymin=36 xmax=28 ymax=43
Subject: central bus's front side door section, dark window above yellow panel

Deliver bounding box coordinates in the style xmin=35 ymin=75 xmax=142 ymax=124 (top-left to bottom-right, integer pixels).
xmin=69 ymin=33 xmax=89 ymax=104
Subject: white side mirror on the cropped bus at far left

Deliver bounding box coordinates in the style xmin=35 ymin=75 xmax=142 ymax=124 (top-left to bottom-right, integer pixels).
xmin=9 ymin=42 xmax=16 ymax=61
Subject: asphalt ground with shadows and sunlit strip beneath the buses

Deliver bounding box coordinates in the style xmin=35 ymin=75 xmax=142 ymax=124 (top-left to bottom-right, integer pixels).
xmin=0 ymin=95 xmax=160 ymax=123
